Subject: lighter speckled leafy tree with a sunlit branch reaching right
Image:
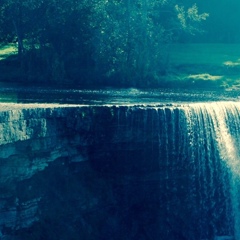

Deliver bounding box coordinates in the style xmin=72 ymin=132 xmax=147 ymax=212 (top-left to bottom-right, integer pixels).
xmin=92 ymin=0 xmax=208 ymax=85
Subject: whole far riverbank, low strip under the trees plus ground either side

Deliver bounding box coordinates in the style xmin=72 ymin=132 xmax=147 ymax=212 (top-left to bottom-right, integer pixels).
xmin=0 ymin=44 xmax=240 ymax=90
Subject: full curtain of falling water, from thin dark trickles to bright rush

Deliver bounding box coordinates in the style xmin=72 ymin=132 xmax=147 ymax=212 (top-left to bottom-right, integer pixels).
xmin=111 ymin=102 xmax=240 ymax=240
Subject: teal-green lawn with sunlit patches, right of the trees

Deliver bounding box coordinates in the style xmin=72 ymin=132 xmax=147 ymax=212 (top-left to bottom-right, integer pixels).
xmin=170 ymin=44 xmax=240 ymax=90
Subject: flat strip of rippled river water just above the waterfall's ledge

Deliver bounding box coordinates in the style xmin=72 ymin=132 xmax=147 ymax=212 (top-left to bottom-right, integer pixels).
xmin=0 ymin=87 xmax=240 ymax=105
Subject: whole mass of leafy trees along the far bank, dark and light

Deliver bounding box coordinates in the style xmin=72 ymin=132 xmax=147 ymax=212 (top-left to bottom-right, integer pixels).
xmin=0 ymin=0 xmax=208 ymax=86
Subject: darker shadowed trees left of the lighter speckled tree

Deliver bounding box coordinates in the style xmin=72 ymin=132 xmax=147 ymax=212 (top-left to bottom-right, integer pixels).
xmin=0 ymin=0 xmax=92 ymax=83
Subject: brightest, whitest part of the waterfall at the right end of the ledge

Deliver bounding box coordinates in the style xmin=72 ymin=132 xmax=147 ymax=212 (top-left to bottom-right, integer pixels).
xmin=182 ymin=102 xmax=240 ymax=239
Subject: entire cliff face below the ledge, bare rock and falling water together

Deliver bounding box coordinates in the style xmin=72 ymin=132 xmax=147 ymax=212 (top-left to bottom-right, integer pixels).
xmin=0 ymin=102 xmax=240 ymax=240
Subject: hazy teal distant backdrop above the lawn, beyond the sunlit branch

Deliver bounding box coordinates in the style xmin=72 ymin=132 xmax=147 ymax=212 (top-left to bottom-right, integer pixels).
xmin=181 ymin=0 xmax=240 ymax=44
